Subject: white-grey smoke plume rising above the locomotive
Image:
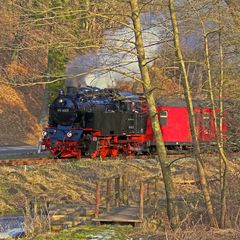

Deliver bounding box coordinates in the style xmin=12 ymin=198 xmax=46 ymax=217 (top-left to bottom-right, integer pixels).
xmin=65 ymin=12 xmax=165 ymax=88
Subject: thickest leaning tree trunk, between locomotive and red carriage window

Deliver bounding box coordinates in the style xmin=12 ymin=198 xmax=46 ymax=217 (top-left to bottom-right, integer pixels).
xmin=130 ymin=0 xmax=179 ymax=228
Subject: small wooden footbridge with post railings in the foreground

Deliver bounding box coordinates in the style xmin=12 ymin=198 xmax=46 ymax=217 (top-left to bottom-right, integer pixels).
xmin=93 ymin=175 xmax=160 ymax=226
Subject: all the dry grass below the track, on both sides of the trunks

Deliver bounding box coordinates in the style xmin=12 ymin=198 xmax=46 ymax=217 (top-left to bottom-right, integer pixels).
xmin=0 ymin=157 xmax=240 ymax=240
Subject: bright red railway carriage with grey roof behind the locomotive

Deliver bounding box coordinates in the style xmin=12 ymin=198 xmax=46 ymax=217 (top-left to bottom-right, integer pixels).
xmin=146 ymin=99 xmax=226 ymax=146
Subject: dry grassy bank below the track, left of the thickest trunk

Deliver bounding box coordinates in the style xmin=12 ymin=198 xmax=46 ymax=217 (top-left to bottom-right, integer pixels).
xmin=0 ymin=160 xmax=159 ymax=214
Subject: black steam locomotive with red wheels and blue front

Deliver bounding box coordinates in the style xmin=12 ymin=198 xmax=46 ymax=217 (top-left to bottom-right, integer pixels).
xmin=42 ymin=87 xmax=148 ymax=158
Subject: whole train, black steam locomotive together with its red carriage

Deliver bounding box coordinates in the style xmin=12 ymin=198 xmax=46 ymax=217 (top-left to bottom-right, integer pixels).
xmin=42 ymin=87 xmax=230 ymax=158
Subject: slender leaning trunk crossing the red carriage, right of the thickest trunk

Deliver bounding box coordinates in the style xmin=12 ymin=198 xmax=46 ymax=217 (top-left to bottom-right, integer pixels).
xmin=169 ymin=0 xmax=218 ymax=227
